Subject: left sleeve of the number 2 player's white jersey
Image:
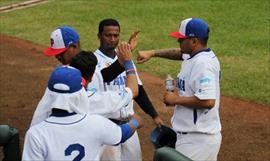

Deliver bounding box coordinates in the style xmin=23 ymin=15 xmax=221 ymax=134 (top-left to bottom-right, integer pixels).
xmin=22 ymin=129 xmax=44 ymax=161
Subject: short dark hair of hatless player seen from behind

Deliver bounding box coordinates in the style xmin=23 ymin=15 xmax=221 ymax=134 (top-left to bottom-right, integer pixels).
xmin=70 ymin=51 xmax=97 ymax=81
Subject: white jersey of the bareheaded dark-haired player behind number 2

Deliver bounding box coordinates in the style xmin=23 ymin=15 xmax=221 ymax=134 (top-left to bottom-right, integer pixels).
xmin=31 ymin=88 xmax=133 ymax=126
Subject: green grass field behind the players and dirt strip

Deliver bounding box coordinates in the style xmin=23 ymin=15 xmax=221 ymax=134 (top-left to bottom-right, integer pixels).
xmin=0 ymin=0 xmax=270 ymax=105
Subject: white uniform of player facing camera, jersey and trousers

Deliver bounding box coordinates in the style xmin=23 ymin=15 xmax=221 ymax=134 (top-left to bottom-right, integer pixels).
xmin=87 ymin=49 xmax=142 ymax=161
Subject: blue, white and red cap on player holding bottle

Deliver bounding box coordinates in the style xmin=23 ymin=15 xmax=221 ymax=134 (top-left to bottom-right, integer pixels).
xmin=170 ymin=18 xmax=209 ymax=39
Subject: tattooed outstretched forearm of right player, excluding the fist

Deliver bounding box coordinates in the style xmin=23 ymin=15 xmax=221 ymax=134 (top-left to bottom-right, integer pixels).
xmin=153 ymin=48 xmax=182 ymax=60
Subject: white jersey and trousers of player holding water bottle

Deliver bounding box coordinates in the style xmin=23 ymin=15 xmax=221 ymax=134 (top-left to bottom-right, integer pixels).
xmin=171 ymin=49 xmax=221 ymax=160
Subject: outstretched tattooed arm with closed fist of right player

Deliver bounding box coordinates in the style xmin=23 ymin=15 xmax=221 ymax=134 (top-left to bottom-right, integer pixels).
xmin=137 ymin=48 xmax=182 ymax=64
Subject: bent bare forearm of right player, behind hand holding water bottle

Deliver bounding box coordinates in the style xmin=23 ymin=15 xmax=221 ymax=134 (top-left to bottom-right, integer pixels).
xmin=175 ymin=96 xmax=215 ymax=109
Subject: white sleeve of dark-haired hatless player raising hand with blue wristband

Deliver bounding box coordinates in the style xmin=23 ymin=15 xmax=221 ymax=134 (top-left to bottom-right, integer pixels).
xmin=86 ymin=88 xmax=133 ymax=115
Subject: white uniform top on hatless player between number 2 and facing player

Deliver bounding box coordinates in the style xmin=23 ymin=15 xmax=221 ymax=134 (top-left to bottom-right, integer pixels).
xmin=31 ymin=70 xmax=133 ymax=126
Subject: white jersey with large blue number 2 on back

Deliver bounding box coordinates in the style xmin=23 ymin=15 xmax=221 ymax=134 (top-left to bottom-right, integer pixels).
xmin=22 ymin=114 xmax=122 ymax=161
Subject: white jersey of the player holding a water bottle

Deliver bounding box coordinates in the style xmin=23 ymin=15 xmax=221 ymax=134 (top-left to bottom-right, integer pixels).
xmin=171 ymin=49 xmax=221 ymax=134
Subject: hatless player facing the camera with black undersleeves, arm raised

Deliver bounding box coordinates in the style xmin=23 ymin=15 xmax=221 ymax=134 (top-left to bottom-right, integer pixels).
xmin=88 ymin=19 xmax=163 ymax=161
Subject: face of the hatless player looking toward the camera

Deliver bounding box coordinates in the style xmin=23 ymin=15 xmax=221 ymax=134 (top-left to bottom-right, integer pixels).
xmin=98 ymin=26 xmax=120 ymax=50
